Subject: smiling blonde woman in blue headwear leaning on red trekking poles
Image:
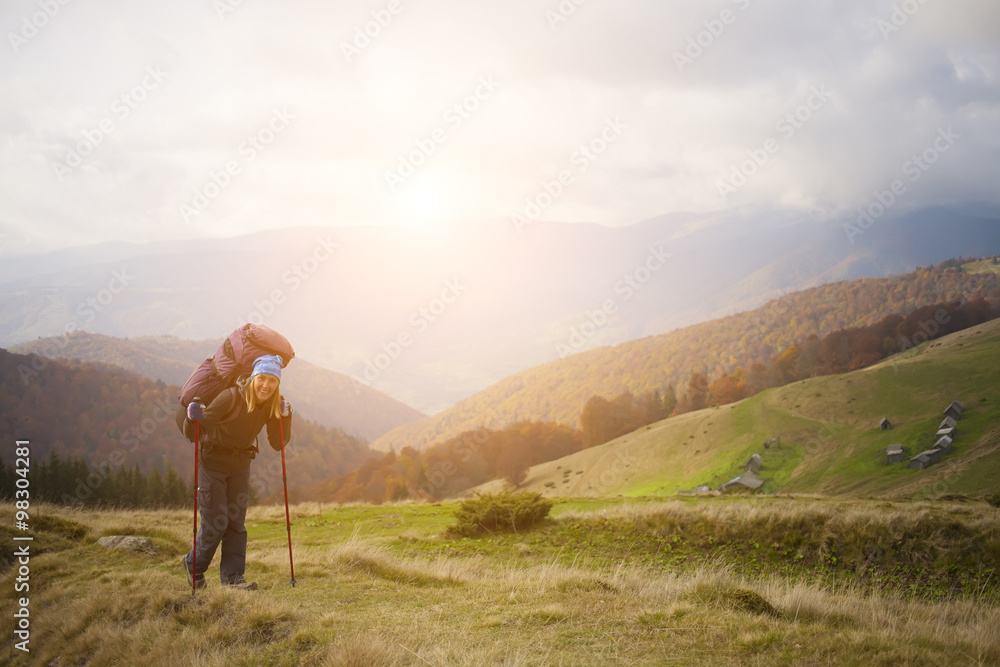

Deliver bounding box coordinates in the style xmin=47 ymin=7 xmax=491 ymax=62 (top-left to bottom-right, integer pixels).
xmin=177 ymin=355 xmax=292 ymax=590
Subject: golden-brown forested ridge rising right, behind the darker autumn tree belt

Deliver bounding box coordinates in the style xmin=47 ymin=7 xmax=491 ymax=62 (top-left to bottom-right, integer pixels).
xmin=373 ymin=260 xmax=1000 ymax=451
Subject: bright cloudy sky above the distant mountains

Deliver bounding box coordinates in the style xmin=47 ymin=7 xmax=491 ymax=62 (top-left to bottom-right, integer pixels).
xmin=0 ymin=0 xmax=1000 ymax=256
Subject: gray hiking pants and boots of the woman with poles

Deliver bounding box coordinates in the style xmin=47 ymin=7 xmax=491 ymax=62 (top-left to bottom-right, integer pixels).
xmin=186 ymin=465 xmax=250 ymax=584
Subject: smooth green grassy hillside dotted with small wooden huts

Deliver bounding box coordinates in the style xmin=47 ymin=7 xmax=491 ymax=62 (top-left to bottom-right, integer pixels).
xmin=480 ymin=321 xmax=1000 ymax=496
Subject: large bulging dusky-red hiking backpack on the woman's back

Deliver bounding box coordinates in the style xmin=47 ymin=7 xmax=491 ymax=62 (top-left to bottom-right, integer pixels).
xmin=178 ymin=324 xmax=295 ymax=407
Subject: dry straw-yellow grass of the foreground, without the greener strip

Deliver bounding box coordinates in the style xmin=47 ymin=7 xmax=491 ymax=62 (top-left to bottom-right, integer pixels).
xmin=0 ymin=499 xmax=1000 ymax=667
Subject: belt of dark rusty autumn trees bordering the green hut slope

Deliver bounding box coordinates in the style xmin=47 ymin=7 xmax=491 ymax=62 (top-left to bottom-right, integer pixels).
xmin=304 ymin=298 xmax=998 ymax=503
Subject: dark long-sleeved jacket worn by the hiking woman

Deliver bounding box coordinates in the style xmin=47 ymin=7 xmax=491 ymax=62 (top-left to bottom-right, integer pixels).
xmin=177 ymin=389 xmax=292 ymax=473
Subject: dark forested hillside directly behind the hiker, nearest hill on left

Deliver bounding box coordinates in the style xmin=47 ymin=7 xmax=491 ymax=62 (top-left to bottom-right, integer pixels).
xmin=0 ymin=349 xmax=370 ymax=496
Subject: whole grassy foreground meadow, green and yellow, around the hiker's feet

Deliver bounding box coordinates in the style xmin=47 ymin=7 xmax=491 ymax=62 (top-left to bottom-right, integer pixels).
xmin=0 ymin=498 xmax=1000 ymax=667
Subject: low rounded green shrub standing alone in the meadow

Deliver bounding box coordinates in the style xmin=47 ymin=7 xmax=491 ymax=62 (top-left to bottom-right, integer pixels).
xmin=448 ymin=490 xmax=552 ymax=537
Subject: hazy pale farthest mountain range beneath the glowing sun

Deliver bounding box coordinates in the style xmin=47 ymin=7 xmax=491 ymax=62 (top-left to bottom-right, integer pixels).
xmin=0 ymin=206 xmax=1000 ymax=418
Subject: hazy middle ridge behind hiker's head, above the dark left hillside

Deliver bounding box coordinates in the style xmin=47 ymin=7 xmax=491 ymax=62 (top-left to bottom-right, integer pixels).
xmin=11 ymin=332 xmax=424 ymax=442
